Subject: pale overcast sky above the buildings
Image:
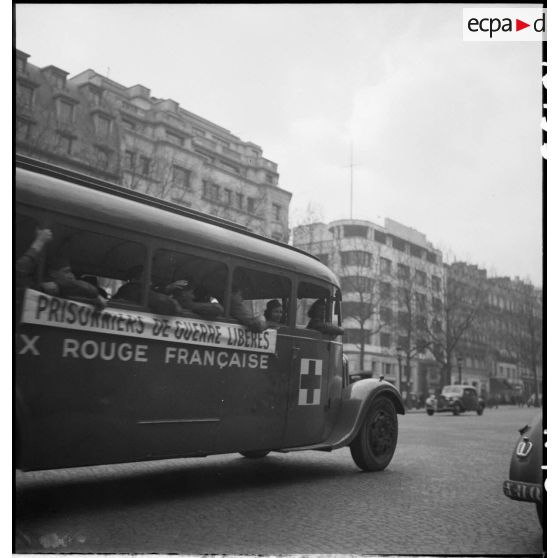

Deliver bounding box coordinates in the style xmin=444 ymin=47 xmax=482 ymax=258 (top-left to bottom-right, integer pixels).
xmin=16 ymin=4 xmax=542 ymax=285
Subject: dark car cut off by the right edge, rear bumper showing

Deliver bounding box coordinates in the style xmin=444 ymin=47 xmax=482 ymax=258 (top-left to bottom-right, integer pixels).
xmin=503 ymin=413 xmax=544 ymax=527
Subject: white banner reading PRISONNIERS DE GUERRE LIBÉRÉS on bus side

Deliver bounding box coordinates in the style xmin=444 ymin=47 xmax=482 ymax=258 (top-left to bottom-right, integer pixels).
xmin=21 ymin=289 xmax=277 ymax=353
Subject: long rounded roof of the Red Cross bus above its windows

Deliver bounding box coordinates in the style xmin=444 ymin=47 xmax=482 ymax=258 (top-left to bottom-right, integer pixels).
xmin=16 ymin=156 xmax=339 ymax=285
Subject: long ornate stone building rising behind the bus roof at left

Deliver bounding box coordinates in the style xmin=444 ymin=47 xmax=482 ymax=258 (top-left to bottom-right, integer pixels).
xmin=15 ymin=50 xmax=292 ymax=241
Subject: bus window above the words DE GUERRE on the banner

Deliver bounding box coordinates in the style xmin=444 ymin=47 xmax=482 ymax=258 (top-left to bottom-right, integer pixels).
xmin=151 ymin=250 xmax=227 ymax=304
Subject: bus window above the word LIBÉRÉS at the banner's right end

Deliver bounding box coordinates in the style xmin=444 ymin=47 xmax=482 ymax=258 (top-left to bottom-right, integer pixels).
xmin=233 ymin=267 xmax=291 ymax=325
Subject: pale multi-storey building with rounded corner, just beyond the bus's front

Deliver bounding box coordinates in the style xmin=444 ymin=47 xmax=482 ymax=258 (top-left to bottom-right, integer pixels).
xmin=293 ymin=219 xmax=445 ymax=400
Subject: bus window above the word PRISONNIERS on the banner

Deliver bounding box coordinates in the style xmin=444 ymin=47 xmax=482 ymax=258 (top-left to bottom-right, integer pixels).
xmin=43 ymin=224 xmax=146 ymax=304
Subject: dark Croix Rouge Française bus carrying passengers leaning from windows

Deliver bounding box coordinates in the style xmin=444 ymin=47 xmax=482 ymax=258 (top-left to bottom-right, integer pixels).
xmin=13 ymin=157 xmax=405 ymax=471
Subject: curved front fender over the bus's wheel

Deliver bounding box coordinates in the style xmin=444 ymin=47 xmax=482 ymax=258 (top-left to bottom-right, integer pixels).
xmin=323 ymin=378 xmax=405 ymax=449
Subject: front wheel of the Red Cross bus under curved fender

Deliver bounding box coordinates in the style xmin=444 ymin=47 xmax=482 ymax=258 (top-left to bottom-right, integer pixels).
xmin=350 ymin=396 xmax=398 ymax=471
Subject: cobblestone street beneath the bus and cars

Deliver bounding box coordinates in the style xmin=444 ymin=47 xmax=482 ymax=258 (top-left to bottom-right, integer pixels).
xmin=16 ymin=407 xmax=544 ymax=556
